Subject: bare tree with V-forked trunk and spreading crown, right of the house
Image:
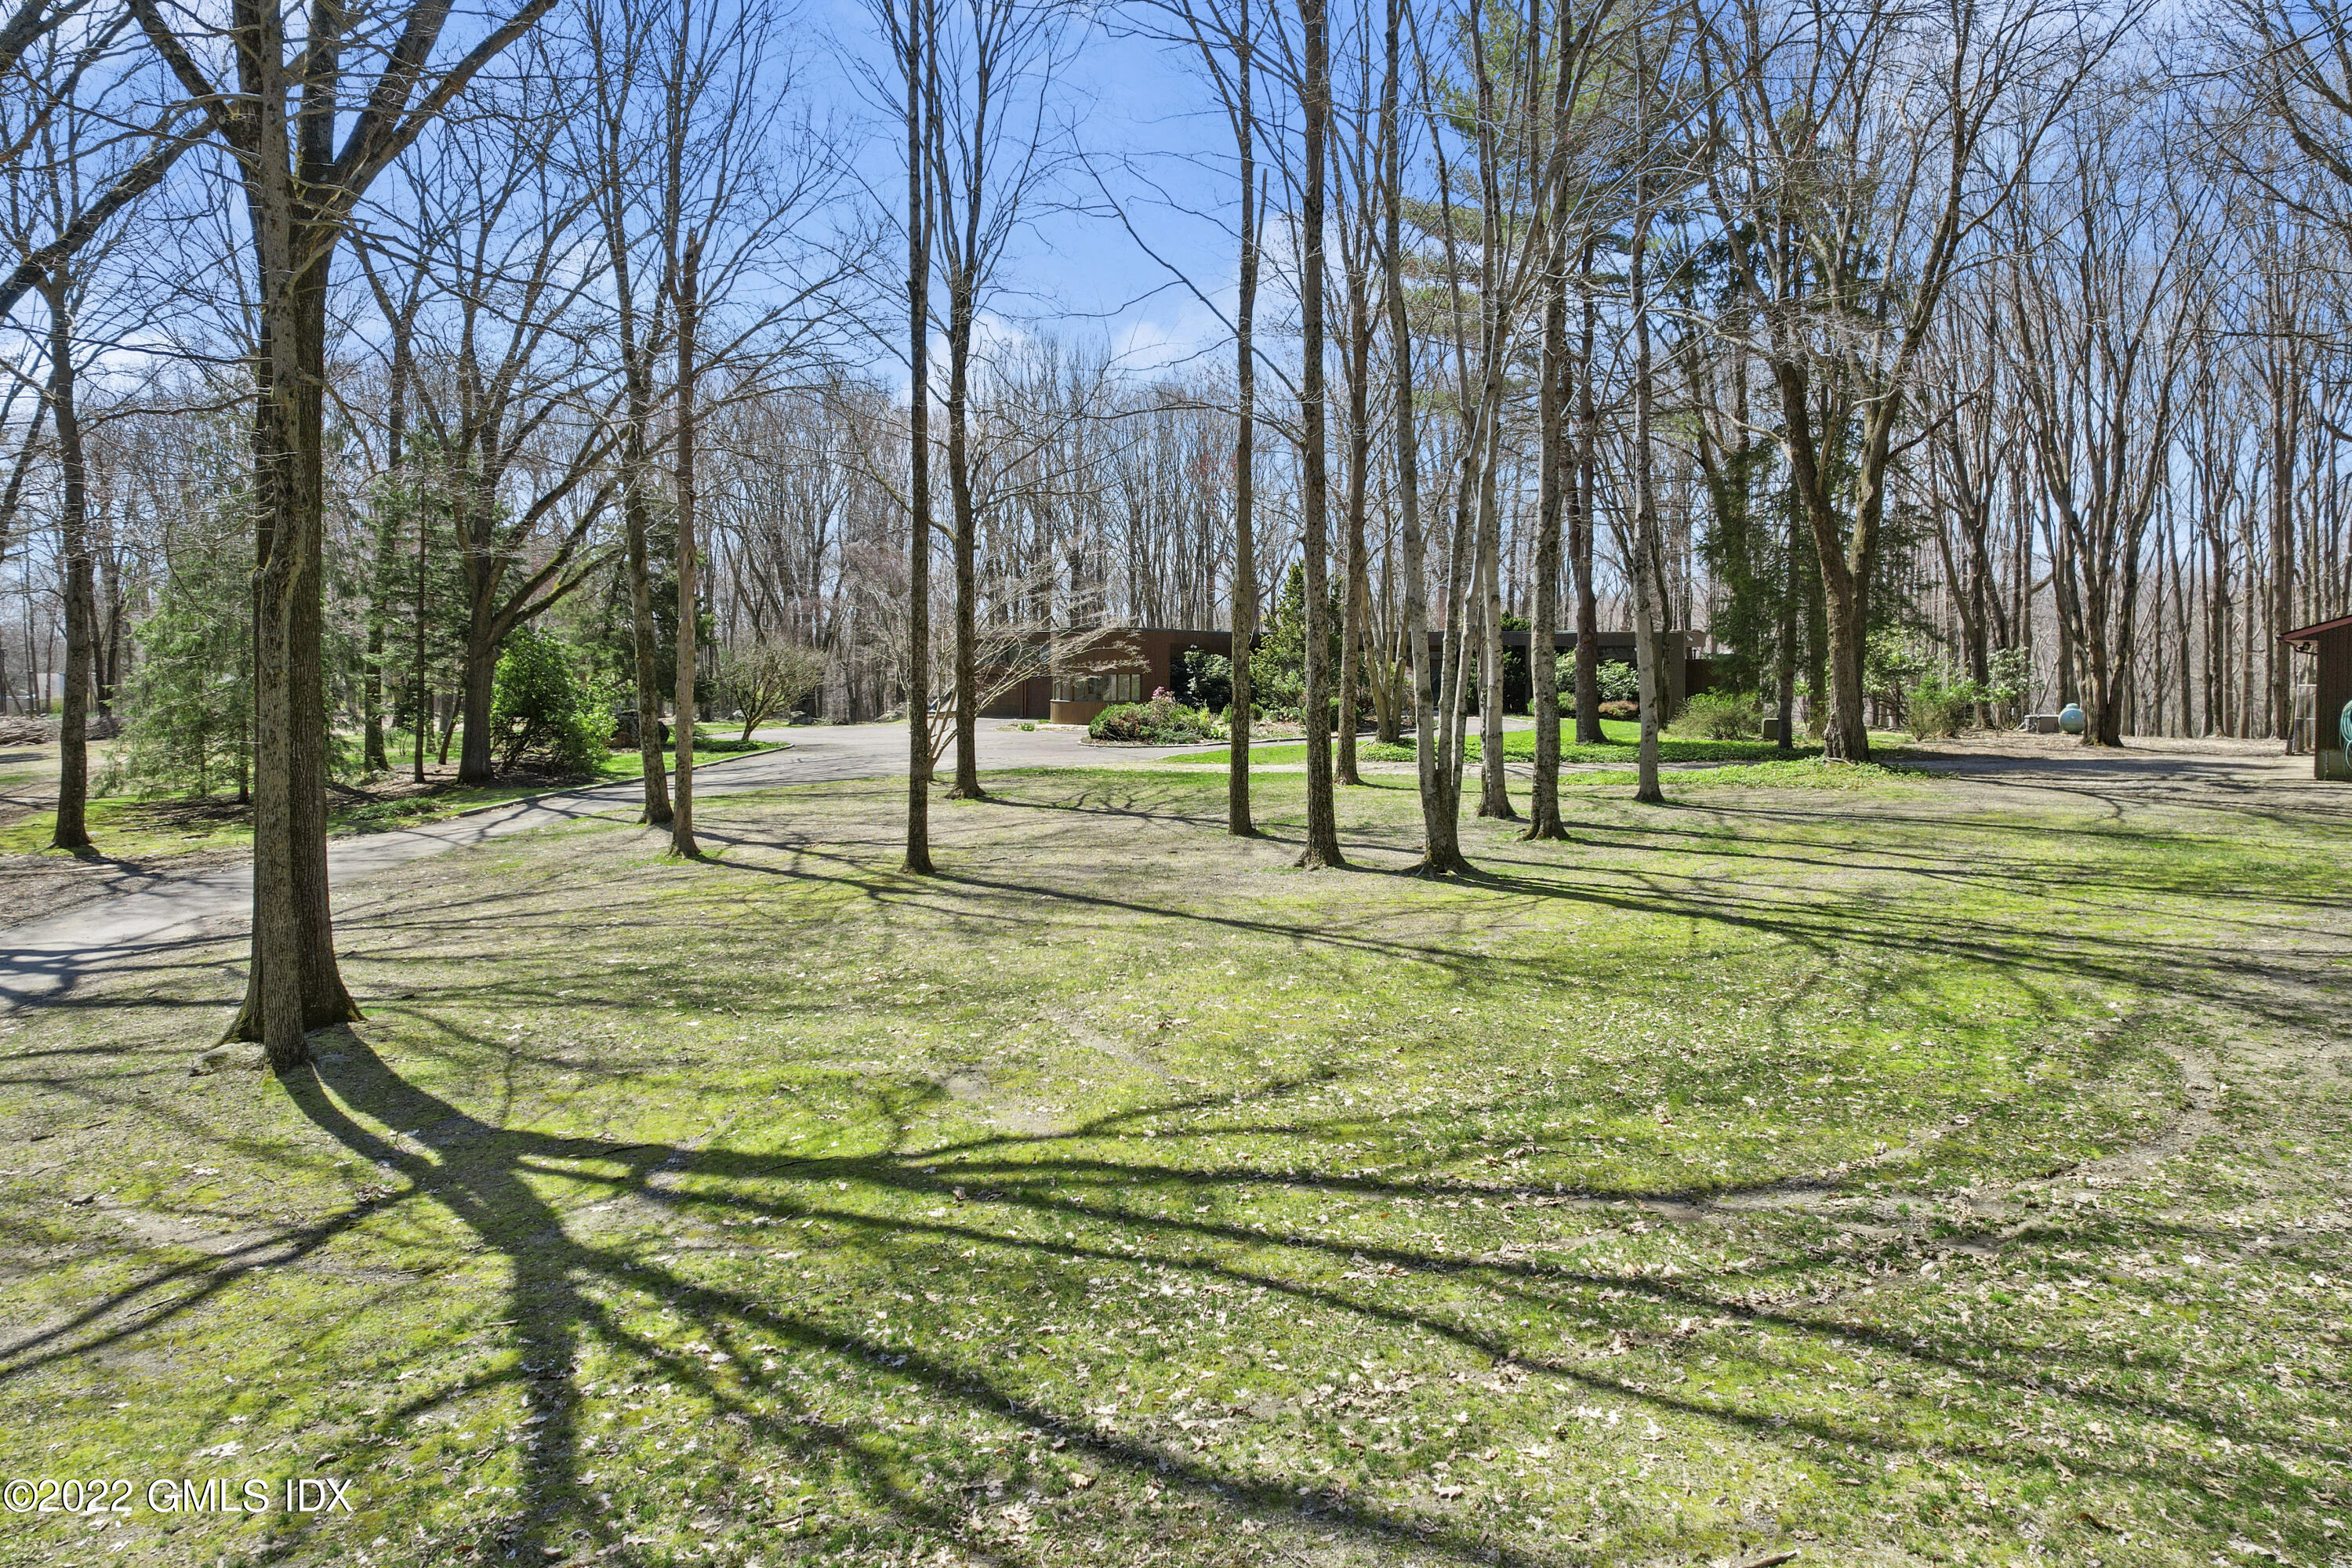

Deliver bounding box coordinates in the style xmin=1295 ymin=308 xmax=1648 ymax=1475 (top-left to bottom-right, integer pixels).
xmin=1700 ymin=0 xmax=2119 ymax=762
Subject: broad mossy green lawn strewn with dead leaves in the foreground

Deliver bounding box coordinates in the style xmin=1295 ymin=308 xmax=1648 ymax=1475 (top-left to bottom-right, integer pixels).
xmin=0 ymin=771 xmax=2352 ymax=1568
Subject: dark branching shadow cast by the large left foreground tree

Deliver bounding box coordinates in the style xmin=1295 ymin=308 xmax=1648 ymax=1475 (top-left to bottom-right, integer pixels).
xmin=13 ymin=1029 xmax=2343 ymax=1563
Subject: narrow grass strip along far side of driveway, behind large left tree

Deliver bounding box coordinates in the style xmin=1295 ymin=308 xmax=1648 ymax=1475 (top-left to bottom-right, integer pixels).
xmin=0 ymin=743 xmax=781 ymax=860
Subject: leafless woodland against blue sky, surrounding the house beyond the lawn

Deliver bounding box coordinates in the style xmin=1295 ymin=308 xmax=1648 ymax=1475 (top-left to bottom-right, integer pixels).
xmin=0 ymin=0 xmax=2352 ymax=1053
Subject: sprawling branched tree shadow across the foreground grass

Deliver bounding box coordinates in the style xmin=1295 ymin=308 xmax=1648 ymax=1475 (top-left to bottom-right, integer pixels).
xmin=0 ymin=1029 xmax=2333 ymax=1568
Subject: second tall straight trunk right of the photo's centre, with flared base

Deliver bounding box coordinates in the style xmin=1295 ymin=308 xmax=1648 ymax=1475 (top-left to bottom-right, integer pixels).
xmin=1298 ymin=0 xmax=1345 ymax=869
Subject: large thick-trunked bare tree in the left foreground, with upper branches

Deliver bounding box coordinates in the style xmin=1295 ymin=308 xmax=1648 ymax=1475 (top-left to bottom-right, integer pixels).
xmin=129 ymin=0 xmax=555 ymax=1072
